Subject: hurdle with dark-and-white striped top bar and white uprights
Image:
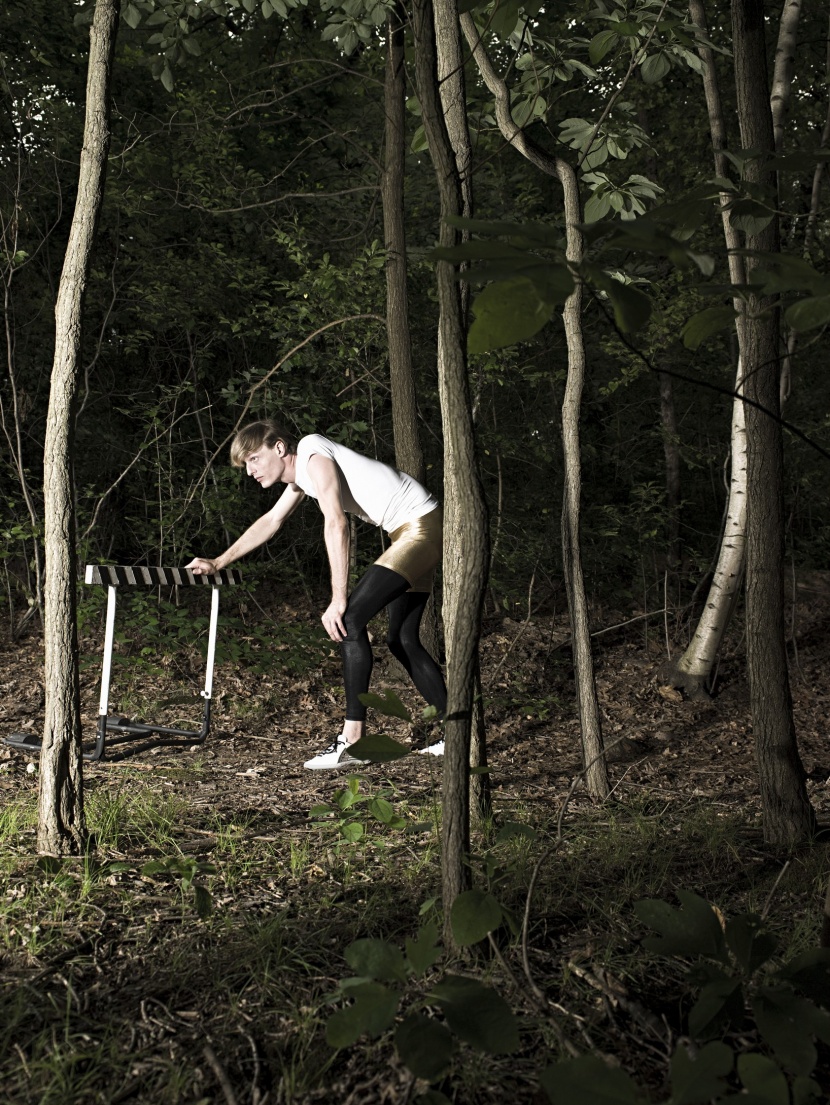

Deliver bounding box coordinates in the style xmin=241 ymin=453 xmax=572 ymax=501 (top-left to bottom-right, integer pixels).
xmin=84 ymin=564 xmax=242 ymax=760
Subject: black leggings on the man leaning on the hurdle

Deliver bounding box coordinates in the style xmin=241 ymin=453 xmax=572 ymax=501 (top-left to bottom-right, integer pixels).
xmin=340 ymin=564 xmax=446 ymax=722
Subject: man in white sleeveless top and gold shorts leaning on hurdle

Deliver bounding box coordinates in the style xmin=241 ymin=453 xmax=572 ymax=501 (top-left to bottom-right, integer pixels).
xmin=188 ymin=419 xmax=446 ymax=770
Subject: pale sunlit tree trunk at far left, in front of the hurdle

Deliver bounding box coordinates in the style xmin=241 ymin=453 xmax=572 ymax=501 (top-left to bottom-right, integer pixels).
xmin=38 ymin=0 xmax=119 ymax=855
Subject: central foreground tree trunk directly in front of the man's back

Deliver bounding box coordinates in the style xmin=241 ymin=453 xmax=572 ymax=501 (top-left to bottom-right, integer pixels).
xmin=412 ymin=0 xmax=487 ymax=944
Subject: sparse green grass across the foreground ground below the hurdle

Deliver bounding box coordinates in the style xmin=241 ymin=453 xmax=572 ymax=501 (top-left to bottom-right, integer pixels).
xmin=0 ymin=765 xmax=827 ymax=1105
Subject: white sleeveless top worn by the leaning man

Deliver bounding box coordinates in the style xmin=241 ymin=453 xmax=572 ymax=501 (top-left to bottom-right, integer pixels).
xmin=294 ymin=433 xmax=438 ymax=534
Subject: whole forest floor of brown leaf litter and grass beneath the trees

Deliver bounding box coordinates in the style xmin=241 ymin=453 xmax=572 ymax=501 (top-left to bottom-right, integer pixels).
xmin=0 ymin=592 xmax=830 ymax=1105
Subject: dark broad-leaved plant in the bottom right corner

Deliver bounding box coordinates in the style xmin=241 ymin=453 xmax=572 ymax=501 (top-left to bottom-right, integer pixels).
xmin=542 ymin=891 xmax=830 ymax=1105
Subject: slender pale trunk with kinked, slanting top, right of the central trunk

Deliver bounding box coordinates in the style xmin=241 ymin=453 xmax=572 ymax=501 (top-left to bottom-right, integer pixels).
xmin=461 ymin=13 xmax=609 ymax=799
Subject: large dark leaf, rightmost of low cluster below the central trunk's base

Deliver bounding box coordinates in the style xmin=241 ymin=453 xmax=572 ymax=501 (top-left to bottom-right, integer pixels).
xmin=428 ymin=975 xmax=519 ymax=1055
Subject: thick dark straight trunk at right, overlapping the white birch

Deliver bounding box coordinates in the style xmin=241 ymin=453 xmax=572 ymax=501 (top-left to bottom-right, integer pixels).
xmin=732 ymin=0 xmax=815 ymax=846
